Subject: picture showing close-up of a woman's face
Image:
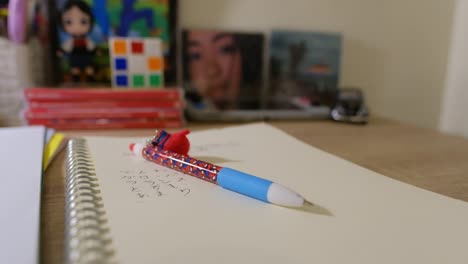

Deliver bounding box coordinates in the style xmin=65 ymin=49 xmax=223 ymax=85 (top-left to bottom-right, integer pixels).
xmin=182 ymin=30 xmax=264 ymax=110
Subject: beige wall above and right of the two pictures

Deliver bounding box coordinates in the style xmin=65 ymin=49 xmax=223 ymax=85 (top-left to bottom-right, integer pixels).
xmin=180 ymin=0 xmax=453 ymax=128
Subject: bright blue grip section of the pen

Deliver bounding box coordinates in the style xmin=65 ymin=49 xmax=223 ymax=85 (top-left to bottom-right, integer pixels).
xmin=217 ymin=168 xmax=272 ymax=202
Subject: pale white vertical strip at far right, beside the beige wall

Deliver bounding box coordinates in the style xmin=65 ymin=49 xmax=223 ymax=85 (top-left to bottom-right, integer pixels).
xmin=441 ymin=0 xmax=468 ymax=137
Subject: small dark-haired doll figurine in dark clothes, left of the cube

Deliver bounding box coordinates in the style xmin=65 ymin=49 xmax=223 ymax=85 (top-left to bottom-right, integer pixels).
xmin=60 ymin=0 xmax=96 ymax=82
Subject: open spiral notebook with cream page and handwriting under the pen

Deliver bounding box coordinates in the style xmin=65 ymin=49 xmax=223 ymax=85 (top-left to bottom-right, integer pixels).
xmin=66 ymin=123 xmax=468 ymax=264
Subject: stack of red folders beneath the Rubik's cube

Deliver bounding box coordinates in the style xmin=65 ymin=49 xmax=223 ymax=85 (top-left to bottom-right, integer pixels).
xmin=24 ymin=88 xmax=184 ymax=130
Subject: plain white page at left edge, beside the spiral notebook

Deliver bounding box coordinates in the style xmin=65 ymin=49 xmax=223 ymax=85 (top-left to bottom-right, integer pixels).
xmin=0 ymin=126 xmax=45 ymax=264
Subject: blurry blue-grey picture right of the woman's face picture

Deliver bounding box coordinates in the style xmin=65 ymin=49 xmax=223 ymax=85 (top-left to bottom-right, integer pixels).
xmin=269 ymin=31 xmax=341 ymax=105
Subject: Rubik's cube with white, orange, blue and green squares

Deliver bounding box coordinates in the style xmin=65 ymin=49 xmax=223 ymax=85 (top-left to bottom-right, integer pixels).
xmin=109 ymin=37 xmax=164 ymax=88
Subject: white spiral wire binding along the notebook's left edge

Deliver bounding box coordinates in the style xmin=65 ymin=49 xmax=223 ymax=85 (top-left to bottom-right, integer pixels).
xmin=65 ymin=138 xmax=115 ymax=264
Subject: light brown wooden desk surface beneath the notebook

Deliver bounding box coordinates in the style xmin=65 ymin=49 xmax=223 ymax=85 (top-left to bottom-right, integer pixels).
xmin=41 ymin=119 xmax=468 ymax=264
